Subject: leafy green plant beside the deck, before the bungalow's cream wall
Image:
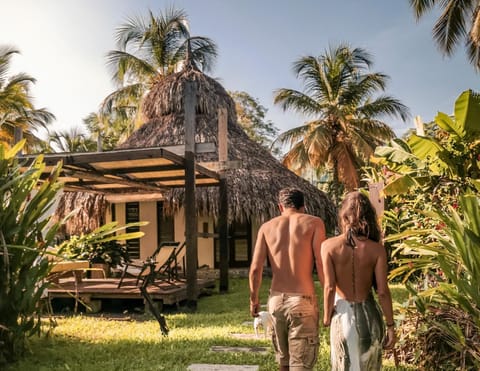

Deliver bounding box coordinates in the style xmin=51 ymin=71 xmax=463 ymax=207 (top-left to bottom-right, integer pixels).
xmin=57 ymin=222 xmax=147 ymax=268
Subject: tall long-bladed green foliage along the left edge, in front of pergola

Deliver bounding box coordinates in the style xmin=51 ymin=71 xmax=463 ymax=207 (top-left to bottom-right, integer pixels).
xmin=0 ymin=141 xmax=62 ymax=364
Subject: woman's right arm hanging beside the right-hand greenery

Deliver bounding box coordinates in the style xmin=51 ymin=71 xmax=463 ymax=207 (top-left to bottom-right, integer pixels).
xmin=375 ymin=246 xmax=396 ymax=348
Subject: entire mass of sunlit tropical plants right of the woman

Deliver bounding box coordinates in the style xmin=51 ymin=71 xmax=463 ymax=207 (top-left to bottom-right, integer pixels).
xmin=375 ymin=91 xmax=480 ymax=370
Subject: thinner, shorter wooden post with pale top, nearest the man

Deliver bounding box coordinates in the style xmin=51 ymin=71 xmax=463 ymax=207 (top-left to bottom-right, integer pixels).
xmin=218 ymin=108 xmax=229 ymax=293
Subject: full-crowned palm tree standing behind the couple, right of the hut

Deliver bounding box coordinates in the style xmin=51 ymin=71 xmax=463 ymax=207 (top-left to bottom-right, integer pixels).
xmin=274 ymin=45 xmax=408 ymax=205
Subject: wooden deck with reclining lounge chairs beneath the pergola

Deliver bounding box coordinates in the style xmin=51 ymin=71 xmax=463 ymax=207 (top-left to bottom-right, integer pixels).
xmin=48 ymin=241 xmax=215 ymax=311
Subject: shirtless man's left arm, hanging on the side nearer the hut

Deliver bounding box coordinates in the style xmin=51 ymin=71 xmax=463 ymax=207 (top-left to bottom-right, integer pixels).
xmin=248 ymin=226 xmax=267 ymax=317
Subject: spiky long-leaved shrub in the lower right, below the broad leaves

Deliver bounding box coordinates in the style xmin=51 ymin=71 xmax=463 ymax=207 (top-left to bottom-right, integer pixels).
xmin=389 ymin=195 xmax=480 ymax=370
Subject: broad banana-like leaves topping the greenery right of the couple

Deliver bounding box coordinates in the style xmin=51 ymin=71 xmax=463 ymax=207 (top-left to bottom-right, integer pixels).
xmin=375 ymin=90 xmax=480 ymax=196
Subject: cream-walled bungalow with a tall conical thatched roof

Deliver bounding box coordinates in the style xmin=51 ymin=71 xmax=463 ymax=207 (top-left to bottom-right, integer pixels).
xmin=53 ymin=63 xmax=336 ymax=267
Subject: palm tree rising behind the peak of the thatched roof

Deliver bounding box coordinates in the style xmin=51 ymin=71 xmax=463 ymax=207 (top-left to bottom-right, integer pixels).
xmin=100 ymin=8 xmax=217 ymax=138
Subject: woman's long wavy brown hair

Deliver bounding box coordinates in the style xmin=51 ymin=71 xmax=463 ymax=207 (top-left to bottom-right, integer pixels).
xmin=338 ymin=191 xmax=381 ymax=242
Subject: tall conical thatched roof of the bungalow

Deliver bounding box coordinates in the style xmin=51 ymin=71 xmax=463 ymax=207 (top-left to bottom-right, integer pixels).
xmin=120 ymin=65 xmax=336 ymax=231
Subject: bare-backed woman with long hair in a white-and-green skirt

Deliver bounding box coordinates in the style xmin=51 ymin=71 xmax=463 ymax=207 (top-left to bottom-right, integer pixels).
xmin=321 ymin=192 xmax=395 ymax=371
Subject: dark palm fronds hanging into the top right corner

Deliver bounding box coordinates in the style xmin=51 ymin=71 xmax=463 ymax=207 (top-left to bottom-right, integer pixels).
xmin=409 ymin=0 xmax=480 ymax=70
